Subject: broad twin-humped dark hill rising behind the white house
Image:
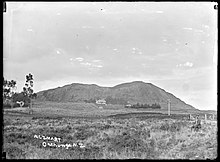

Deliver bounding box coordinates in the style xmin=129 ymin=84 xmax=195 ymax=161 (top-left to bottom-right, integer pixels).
xmin=37 ymin=81 xmax=197 ymax=110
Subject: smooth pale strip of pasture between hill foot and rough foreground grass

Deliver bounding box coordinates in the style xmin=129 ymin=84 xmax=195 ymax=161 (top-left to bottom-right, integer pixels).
xmin=4 ymin=102 xmax=206 ymax=118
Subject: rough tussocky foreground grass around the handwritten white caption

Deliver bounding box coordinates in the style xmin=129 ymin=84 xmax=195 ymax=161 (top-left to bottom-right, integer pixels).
xmin=3 ymin=117 xmax=217 ymax=159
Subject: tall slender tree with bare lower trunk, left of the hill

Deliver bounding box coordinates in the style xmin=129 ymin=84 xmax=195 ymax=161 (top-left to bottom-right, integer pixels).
xmin=23 ymin=73 xmax=37 ymax=111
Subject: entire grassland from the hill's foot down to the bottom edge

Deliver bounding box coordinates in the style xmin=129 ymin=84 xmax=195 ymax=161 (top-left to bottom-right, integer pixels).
xmin=3 ymin=102 xmax=217 ymax=159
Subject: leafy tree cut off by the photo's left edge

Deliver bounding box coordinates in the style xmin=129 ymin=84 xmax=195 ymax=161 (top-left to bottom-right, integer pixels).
xmin=3 ymin=77 xmax=16 ymax=108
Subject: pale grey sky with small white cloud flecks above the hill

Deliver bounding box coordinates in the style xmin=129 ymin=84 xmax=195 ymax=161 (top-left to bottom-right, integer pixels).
xmin=3 ymin=2 xmax=218 ymax=110
